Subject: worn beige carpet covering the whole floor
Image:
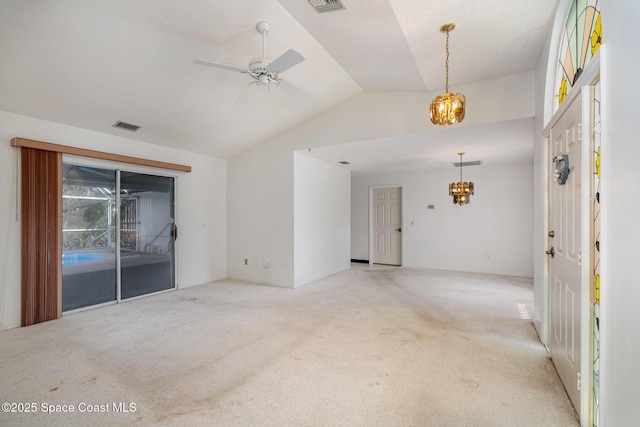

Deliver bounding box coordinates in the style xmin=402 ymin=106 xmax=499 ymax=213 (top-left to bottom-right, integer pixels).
xmin=0 ymin=264 xmax=577 ymax=427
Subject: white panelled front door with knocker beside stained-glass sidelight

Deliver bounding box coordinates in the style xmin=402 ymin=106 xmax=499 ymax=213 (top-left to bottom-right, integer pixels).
xmin=547 ymin=97 xmax=588 ymax=408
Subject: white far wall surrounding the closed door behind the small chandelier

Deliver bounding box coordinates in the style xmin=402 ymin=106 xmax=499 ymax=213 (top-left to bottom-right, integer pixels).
xmin=351 ymin=163 xmax=533 ymax=277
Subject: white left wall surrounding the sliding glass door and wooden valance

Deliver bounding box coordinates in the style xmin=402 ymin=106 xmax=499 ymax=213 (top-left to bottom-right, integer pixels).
xmin=0 ymin=111 xmax=227 ymax=330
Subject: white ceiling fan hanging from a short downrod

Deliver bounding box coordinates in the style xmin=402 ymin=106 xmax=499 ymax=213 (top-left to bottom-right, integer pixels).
xmin=193 ymin=21 xmax=304 ymax=90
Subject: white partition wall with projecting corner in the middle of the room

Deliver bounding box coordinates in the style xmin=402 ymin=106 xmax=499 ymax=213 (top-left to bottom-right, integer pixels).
xmin=227 ymin=141 xmax=350 ymax=287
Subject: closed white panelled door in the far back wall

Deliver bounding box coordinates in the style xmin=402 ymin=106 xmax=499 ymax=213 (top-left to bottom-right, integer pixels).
xmin=369 ymin=187 xmax=402 ymax=265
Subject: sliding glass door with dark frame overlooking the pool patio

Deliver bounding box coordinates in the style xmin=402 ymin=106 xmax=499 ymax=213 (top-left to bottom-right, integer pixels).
xmin=62 ymin=164 xmax=176 ymax=311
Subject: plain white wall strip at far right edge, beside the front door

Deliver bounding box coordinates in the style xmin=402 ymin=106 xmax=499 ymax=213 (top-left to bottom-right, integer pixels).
xmin=600 ymin=0 xmax=640 ymax=426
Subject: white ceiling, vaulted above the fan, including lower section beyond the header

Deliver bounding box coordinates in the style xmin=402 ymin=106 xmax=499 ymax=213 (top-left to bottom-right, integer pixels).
xmin=0 ymin=0 xmax=559 ymax=168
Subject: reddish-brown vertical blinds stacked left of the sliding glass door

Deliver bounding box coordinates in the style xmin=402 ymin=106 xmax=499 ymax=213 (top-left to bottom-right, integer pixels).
xmin=21 ymin=147 xmax=62 ymax=326
